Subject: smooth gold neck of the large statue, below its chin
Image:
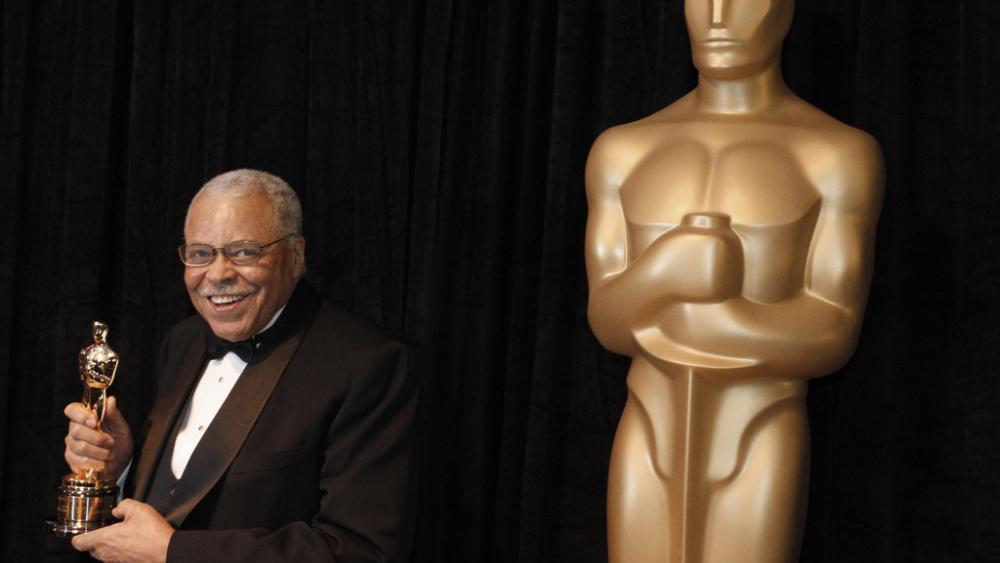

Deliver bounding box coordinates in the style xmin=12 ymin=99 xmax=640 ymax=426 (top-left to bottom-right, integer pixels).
xmin=696 ymin=58 xmax=790 ymax=115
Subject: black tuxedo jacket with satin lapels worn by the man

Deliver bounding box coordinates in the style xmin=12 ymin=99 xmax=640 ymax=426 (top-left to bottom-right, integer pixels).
xmin=126 ymin=282 xmax=417 ymax=562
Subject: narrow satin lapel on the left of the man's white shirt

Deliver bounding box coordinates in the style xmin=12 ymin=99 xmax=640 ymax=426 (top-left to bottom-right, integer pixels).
xmin=134 ymin=338 xmax=205 ymax=502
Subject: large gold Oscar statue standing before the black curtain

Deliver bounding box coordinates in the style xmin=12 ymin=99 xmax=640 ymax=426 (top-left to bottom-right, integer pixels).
xmin=586 ymin=0 xmax=883 ymax=563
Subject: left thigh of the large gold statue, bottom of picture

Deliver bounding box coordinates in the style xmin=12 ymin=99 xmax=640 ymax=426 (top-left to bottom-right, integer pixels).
xmin=608 ymin=391 xmax=670 ymax=563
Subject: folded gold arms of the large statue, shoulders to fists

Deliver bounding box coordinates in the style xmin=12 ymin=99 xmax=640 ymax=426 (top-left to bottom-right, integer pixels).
xmin=586 ymin=124 xmax=883 ymax=379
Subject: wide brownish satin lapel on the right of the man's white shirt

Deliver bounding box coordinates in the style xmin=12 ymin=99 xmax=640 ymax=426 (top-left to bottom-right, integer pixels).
xmin=157 ymin=332 xmax=302 ymax=527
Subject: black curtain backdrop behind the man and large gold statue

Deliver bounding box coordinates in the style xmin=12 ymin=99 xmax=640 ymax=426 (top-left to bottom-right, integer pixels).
xmin=0 ymin=0 xmax=1000 ymax=563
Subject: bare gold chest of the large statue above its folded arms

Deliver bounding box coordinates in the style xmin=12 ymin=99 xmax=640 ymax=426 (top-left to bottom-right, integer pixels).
xmin=620 ymin=121 xmax=822 ymax=302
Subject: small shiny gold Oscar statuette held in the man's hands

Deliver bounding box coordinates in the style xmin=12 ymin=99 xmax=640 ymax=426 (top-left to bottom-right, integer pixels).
xmin=47 ymin=321 xmax=118 ymax=537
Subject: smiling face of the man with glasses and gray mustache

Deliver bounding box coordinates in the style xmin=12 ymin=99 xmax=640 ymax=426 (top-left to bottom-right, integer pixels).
xmin=184 ymin=194 xmax=305 ymax=341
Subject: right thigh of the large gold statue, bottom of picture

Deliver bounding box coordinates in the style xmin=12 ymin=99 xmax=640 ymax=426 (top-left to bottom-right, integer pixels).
xmin=704 ymin=400 xmax=809 ymax=563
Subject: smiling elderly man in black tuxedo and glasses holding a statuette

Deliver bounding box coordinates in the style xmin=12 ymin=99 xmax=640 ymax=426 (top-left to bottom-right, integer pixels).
xmin=66 ymin=170 xmax=416 ymax=562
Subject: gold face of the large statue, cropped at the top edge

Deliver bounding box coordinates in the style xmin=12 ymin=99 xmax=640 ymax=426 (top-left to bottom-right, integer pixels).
xmin=684 ymin=0 xmax=794 ymax=79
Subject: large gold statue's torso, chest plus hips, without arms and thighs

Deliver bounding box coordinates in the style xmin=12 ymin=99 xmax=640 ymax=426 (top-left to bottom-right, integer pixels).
xmin=596 ymin=100 xmax=872 ymax=479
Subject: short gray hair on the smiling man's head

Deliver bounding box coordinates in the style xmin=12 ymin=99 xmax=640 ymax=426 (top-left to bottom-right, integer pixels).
xmin=184 ymin=168 xmax=302 ymax=235
